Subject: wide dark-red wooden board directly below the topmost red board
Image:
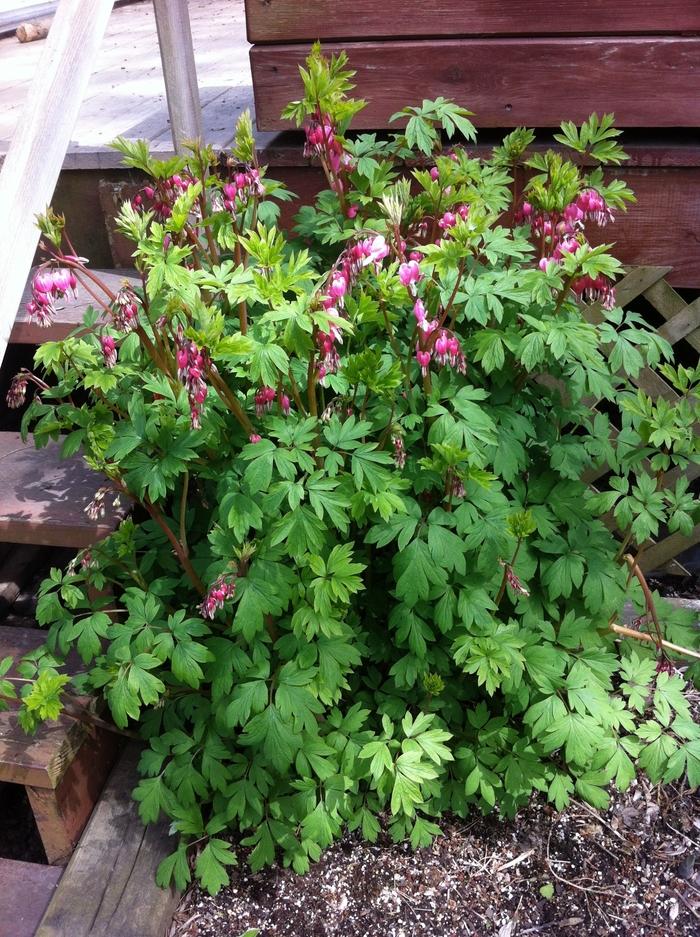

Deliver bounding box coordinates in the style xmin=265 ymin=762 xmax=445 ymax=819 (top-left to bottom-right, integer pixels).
xmin=250 ymin=37 xmax=700 ymax=130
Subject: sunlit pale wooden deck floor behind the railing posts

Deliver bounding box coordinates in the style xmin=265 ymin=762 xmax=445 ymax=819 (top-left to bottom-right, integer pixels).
xmin=0 ymin=0 xmax=260 ymax=169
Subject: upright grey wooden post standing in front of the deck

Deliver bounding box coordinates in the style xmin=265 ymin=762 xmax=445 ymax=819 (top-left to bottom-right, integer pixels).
xmin=153 ymin=0 xmax=203 ymax=152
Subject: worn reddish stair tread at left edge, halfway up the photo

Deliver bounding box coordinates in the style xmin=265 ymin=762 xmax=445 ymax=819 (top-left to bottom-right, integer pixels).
xmin=0 ymin=433 xmax=120 ymax=549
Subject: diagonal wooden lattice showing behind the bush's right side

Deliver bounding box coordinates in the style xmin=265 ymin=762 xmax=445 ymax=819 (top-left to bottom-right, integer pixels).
xmin=586 ymin=267 xmax=700 ymax=576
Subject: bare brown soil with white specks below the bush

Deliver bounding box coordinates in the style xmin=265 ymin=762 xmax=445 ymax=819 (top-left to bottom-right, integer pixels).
xmin=169 ymin=780 xmax=700 ymax=937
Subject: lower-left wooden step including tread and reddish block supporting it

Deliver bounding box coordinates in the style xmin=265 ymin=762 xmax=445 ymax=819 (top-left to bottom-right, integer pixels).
xmin=0 ymin=626 xmax=118 ymax=868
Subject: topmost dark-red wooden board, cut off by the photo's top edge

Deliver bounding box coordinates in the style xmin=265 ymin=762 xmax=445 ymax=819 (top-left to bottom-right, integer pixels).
xmin=245 ymin=0 xmax=700 ymax=42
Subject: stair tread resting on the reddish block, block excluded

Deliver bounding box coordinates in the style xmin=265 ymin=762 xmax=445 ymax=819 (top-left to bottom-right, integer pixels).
xmin=0 ymin=625 xmax=86 ymax=788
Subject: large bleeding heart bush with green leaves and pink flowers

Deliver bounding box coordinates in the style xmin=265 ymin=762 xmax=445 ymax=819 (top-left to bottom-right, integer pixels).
xmin=5 ymin=48 xmax=700 ymax=892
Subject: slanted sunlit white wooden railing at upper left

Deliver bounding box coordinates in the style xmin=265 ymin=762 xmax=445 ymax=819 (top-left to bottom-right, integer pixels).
xmin=0 ymin=0 xmax=113 ymax=372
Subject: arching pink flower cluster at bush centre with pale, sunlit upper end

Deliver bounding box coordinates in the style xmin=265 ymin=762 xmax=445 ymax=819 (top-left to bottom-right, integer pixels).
xmin=316 ymin=234 xmax=389 ymax=381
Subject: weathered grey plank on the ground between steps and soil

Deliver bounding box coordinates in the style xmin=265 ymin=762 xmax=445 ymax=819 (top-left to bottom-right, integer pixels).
xmin=36 ymin=745 xmax=178 ymax=937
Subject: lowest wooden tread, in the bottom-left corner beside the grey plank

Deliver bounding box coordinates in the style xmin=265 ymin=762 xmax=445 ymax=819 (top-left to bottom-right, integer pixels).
xmin=0 ymin=859 xmax=63 ymax=937
